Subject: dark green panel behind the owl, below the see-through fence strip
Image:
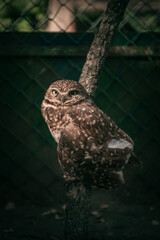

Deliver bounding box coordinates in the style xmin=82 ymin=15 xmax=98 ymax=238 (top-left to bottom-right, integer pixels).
xmin=0 ymin=33 xmax=160 ymax=240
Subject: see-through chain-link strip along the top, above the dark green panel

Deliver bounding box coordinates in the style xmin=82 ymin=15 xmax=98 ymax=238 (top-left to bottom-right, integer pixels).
xmin=0 ymin=0 xmax=160 ymax=32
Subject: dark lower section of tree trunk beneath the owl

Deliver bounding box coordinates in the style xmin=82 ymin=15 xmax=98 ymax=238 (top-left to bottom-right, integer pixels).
xmin=65 ymin=182 xmax=90 ymax=240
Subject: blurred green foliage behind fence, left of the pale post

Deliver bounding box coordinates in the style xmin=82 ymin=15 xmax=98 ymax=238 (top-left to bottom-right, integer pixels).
xmin=0 ymin=0 xmax=48 ymax=32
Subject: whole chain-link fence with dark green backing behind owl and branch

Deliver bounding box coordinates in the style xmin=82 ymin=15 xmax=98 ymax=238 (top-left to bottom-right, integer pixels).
xmin=0 ymin=0 xmax=160 ymax=206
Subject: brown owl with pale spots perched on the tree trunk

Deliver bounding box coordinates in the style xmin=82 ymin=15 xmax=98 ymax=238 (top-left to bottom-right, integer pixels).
xmin=41 ymin=80 xmax=136 ymax=189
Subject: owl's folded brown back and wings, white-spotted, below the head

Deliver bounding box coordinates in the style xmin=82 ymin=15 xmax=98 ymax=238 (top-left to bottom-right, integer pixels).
xmin=58 ymin=104 xmax=138 ymax=189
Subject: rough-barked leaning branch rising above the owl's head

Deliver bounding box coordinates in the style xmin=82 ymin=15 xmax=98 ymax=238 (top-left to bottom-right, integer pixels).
xmin=79 ymin=0 xmax=129 ymax=95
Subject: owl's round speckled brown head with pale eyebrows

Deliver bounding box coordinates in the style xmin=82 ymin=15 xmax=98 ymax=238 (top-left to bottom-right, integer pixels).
xmin=45 ymin=80 xmax=90 ymax=107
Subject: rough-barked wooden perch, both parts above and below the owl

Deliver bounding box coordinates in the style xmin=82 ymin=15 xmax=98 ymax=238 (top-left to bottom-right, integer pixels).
xmin=65 ymin=0 xmax=129 ymax=240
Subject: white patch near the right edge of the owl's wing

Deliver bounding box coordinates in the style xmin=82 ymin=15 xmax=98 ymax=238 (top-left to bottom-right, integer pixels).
xmin=108 ymin=138 xmax=133 ymax=149
